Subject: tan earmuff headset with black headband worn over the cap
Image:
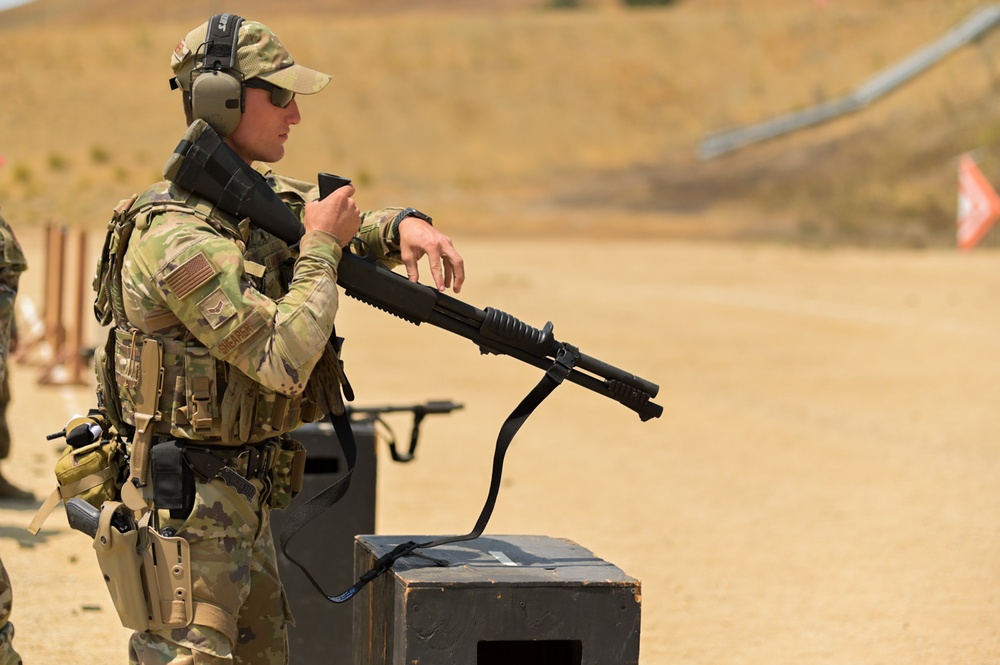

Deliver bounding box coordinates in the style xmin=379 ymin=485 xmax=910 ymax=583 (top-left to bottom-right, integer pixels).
xmin=190 ymin=14 xmax=244 ymax=136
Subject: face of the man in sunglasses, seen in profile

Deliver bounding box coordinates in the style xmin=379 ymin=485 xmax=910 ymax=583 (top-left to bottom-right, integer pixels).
xmin=226 ymin=88 xmax=302 ymax=163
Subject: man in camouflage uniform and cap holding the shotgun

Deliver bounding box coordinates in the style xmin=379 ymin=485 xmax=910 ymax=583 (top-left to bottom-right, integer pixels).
xmin=98 ymin=15 xmax=464 ymax=665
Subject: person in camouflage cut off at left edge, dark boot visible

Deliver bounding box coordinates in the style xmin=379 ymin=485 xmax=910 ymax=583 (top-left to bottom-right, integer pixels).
xmin=0 ymin=210 xmax=35 ymax=500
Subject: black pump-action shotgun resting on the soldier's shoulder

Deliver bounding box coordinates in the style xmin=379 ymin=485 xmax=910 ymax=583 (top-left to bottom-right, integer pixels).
xmin=163 ymin=120 xmax=663 ymax=421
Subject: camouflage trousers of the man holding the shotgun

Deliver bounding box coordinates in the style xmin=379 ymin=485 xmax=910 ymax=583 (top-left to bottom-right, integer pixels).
xmin=129 ymin=480 xmax=292 ymax=665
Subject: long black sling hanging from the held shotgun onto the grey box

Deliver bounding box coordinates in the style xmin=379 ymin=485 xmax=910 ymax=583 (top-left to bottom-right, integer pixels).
xmin=279 ymin=343 xmax=580 ymax=603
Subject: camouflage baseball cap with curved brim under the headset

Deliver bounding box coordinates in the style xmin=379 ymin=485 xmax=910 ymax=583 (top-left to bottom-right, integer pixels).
xmin=170 ymin=21 xmax=331 ymax=95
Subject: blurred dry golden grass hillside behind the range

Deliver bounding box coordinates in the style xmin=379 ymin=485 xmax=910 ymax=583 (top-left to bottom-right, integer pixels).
xmin=0 ymin=0 xmax=1000 ymax=247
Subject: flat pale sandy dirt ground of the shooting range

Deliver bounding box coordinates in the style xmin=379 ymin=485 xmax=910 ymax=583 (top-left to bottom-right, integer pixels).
xmin=0 ymin=220 xmax=1000 ymax=665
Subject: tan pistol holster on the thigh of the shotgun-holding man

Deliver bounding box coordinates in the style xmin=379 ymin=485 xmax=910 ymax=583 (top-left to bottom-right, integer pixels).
xmin=94 ymin=501 xmax=150 ymax=632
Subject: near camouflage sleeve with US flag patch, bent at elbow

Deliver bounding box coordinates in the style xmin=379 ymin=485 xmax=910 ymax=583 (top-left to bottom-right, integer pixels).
xmin=122 ymin=213 xmax=341 ymax=395
